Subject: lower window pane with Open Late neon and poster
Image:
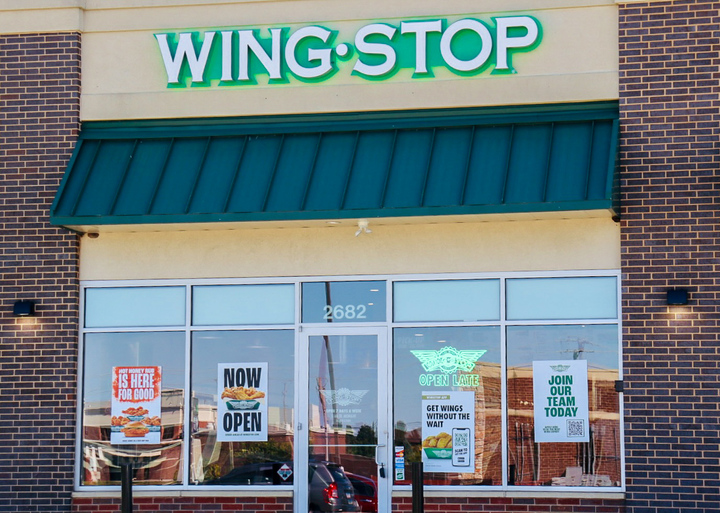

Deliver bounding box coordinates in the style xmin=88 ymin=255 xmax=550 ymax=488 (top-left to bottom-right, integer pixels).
xmin=393 ymin=326 xmax=502 ymax=486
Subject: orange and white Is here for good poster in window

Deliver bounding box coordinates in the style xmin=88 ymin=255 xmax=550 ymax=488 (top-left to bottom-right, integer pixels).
xmin=110 ymin=366 xmax=162 ymax=445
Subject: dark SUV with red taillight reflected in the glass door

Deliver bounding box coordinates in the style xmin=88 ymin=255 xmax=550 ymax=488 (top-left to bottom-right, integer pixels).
xmin=308 ymin=461 xmax=360 ymax=512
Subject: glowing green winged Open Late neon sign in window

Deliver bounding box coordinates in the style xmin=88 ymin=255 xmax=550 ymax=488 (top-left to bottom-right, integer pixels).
xmin=410 ymin=346 xmax=487 ymax=387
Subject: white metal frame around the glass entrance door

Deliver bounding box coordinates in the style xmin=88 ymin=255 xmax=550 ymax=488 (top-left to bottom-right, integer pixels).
xmin=293 ymin=324 xmax=394 ymax=513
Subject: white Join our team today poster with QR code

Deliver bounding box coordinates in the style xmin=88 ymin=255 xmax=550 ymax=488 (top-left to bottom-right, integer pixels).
xmin=533 ymin=360 xmax=590 ymax=442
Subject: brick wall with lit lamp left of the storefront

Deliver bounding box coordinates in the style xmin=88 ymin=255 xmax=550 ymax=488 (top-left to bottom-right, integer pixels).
xmin=0 ymin=34 xmax=80 ymax=513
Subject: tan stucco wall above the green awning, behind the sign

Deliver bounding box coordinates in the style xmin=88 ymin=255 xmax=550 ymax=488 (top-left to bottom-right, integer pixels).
xmin=0 ymin=0 xmax=618 ymax=120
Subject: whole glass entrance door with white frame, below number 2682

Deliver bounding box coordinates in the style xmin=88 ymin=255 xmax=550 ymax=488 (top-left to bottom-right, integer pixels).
xmin=296 ymin=328 xmax=390 ymax=513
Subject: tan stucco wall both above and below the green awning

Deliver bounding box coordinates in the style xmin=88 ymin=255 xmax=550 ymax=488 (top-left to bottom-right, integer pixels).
xmin=0 ymin=0 xmax=620 ymax=280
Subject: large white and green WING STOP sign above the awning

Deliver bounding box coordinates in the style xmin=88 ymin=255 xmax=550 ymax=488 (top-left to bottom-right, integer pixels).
xmin=155 ymin=16 xmax=542 ymax=87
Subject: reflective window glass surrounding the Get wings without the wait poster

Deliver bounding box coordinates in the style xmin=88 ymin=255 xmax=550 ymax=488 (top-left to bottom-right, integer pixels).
xmin=393 ymin=326 xmax=502 ymax=486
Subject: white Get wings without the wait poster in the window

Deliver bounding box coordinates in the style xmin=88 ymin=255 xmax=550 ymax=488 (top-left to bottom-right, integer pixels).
xmin=422 ymin=392 xmax=475 ymax=473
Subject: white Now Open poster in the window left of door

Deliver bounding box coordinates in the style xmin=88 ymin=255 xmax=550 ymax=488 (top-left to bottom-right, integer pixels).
xmin=217 ymin=362 xmax=268 ymax=442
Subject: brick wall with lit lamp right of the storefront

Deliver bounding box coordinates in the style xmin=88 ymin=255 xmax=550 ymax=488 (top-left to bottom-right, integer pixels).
xmin=620 ymin=0 xmax=720 ymax=513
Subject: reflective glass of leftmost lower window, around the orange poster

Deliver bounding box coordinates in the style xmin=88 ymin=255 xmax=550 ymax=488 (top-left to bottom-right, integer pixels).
xmin=82 ymin=332 xmax=185 ymax=485
